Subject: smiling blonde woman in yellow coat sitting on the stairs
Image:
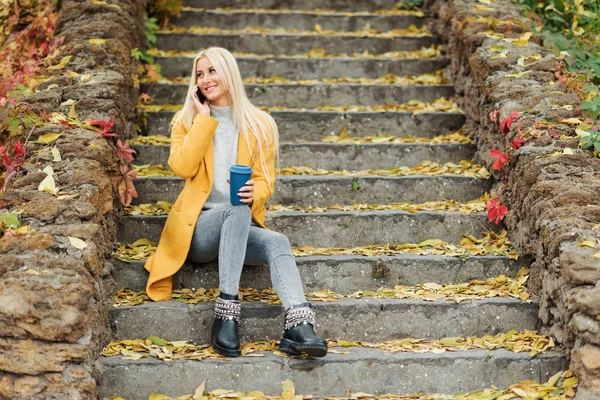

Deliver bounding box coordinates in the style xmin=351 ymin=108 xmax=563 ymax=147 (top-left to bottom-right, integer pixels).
xmin=145 ymin=47 xmax=327 ymax=357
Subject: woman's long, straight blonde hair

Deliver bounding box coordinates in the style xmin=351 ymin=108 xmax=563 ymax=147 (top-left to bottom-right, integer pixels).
xmin=171 ymin=47 xmax=279 ymax=184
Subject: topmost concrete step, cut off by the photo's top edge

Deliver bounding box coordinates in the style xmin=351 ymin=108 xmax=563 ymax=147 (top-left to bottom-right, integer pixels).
xmin=181 ymin=0 xmax=397 ymax=11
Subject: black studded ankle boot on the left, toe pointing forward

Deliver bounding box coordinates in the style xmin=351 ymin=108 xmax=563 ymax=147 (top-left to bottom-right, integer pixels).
xmin=212 ymin=293 xmax=242 ymax=357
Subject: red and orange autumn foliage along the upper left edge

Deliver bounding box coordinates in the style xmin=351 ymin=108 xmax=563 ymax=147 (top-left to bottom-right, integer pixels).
xmin=0 ymin=0 xmax=64 ymax=191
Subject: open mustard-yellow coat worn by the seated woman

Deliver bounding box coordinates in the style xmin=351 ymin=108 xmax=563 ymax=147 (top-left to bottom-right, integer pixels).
xmin=144 ymin=114 xmax=275 ymax=301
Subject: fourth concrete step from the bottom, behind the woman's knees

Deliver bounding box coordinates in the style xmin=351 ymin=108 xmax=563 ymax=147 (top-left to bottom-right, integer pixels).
xmin=117 ymin=210 xmax=499 ymax=247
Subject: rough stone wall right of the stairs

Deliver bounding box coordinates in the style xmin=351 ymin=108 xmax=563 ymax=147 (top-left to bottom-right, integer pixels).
xmin=425 ymin=0 xmax=600 ymax=399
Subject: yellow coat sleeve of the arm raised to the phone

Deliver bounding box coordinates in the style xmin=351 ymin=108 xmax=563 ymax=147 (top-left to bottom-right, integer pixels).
xmin=169 ymin=113 xmax=219 ymax=179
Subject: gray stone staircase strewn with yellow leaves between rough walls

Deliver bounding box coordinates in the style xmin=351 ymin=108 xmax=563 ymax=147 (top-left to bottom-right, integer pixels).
xmin=101 ymin=0 xmax=566 ymax=400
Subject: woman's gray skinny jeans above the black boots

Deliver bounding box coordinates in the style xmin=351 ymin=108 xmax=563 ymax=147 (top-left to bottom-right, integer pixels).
xmin=188 ymin=204 xmax=306 ymax=310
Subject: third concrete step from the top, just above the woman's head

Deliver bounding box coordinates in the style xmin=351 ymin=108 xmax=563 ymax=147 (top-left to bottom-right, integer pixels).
xmin=156 ymin=32 xmax=439 ymax=55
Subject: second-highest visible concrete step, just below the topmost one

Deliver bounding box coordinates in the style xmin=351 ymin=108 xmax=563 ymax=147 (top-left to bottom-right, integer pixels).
xmin=171 ymin=6 xmax=423 ymax=32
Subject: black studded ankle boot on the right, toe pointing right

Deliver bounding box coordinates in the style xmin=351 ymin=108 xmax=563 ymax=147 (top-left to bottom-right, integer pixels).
xmin=279 ymin=303 xmax=327 ymax=357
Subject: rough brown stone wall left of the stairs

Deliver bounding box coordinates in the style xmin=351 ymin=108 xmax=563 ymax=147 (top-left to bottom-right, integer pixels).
xmin=0 ymin=0 xmax=145 ymax=400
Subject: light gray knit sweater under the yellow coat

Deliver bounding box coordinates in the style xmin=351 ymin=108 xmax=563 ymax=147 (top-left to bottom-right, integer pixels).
xmin=204 ymin=104 xmax=239 ymax=208
